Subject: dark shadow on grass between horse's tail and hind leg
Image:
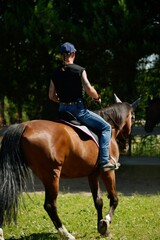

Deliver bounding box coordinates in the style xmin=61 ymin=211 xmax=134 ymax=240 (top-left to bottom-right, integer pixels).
xmin=6 ymin=233 xmax=59 ymax=240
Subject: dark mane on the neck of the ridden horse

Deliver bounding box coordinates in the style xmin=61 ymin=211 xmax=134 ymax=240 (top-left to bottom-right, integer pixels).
xmin=95 ymin=102 xmax=131 ymax=129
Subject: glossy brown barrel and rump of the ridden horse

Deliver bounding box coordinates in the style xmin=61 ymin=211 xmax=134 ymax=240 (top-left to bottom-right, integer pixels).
xmin=21 ymin=120 xmax=98 ymax=178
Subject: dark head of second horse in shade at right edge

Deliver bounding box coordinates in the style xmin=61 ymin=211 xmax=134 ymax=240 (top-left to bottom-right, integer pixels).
xmin=144 ymin=97 xmax=160 ymax=132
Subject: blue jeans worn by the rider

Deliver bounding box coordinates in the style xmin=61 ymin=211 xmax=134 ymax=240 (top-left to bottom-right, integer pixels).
xmin=59 ymin=100 xmax=111 ymax=165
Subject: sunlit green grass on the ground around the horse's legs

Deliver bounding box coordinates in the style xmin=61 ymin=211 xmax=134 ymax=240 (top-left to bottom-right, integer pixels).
xmin=3 ymin=193 xmax=160 ymax=240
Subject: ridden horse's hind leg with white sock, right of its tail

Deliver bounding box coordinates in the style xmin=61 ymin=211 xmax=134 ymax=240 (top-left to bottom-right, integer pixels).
xmin=44 ymin=172 xmax=75 ymax=240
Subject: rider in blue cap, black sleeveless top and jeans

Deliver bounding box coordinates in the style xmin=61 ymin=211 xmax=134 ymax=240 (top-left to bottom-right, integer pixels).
xmin=49 ymin=42 xmax=118 ymax=171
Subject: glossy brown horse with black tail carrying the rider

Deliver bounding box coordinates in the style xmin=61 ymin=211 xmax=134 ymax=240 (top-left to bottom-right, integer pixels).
xmin=0 ymin=95 xmax=137 ymax=240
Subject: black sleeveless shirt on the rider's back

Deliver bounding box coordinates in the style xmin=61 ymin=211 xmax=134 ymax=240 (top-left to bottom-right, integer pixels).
xmin=51 ymin=64 xmax=84 ymax=103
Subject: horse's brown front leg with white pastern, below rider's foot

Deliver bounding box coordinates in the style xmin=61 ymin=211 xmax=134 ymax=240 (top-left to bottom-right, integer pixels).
xmin=99 ymin=170 xmax=118 ymax=235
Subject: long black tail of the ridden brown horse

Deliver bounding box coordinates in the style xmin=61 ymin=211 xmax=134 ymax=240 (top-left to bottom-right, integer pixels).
xmin=0 ymin=124 xmax=33 ymax=224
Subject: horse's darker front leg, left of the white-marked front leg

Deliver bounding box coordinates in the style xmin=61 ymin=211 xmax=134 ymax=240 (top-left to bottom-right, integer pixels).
xmin=88 ymin=172 xmax=103 ymax=235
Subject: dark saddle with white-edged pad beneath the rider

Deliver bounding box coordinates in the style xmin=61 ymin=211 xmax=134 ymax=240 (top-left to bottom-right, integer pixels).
xmin=59 ymin=111 xmax=99 ymax=147
